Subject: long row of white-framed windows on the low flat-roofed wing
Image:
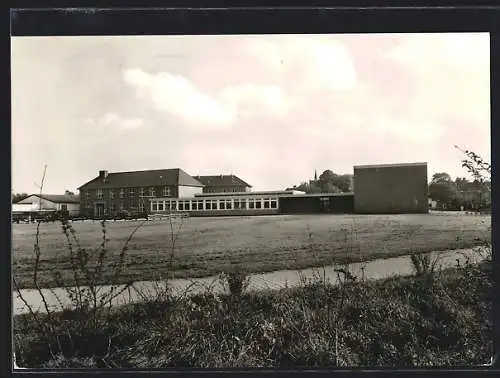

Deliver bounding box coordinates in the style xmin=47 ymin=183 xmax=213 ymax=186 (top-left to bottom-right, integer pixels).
xmin=151 ymin=198 xmax=278 ymax=212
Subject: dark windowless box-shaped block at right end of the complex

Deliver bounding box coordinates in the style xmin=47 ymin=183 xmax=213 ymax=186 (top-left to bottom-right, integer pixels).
xmin=354 ymin=164 xmax=429 ymax=214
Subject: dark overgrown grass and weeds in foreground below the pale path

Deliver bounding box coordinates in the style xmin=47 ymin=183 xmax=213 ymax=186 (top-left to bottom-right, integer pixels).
xmin=14 ymin=255 xmax=493 ymax=368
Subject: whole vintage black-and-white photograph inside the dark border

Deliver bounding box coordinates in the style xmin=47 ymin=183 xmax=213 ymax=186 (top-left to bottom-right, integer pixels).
xmin=11 ymin=33 xmax=494 ymax=369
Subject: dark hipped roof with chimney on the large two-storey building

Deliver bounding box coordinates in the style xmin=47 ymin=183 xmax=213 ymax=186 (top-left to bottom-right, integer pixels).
xmin=78 ymin=168 xmax=203 ymax=190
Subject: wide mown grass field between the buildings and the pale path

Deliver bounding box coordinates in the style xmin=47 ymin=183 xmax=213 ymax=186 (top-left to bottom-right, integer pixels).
xmin=12 ymin=214 xmax=491 ymax=288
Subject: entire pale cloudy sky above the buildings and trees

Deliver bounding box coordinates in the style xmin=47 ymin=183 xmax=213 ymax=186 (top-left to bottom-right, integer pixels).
xmin=11 ymin=33 xmax=490 ymax=194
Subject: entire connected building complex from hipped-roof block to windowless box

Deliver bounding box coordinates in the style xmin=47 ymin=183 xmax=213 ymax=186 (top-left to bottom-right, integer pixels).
xmin=78 ymin=163 xmax=429 ymax=218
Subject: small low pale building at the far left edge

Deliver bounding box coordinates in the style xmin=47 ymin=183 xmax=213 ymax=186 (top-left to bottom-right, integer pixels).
xmin=12 ymin=194 xmax=80 ymax=215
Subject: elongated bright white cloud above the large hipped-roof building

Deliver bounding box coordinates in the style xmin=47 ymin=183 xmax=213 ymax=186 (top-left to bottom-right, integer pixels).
xmin=124 ymin=68 xmax=286 ymax=129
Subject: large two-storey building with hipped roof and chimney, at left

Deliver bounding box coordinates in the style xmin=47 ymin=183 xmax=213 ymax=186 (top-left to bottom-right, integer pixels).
xmin=78 ymin=168 xmax=203 ymax=217
